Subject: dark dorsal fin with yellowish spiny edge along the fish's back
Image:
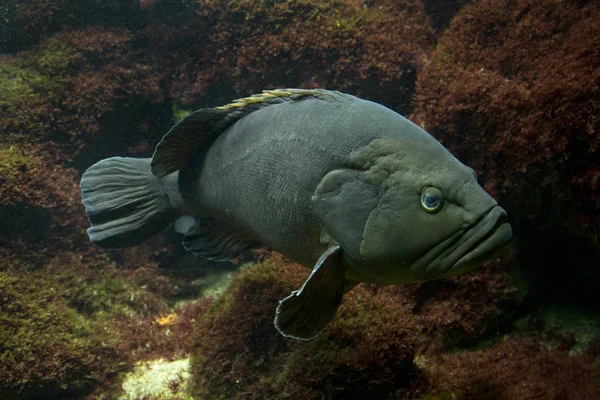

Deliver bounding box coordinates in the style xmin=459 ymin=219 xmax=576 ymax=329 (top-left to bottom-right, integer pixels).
xmin=151 ymin=89 xmax=356 ymax=177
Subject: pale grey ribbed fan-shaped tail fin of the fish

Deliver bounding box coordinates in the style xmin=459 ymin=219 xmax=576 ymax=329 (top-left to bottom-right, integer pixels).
xmin=81 ymin=157 xmax=178 ymax=248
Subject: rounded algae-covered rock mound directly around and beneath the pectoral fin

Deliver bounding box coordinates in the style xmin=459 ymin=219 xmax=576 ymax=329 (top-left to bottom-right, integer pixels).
xmin=191 ymin=259 xmax=422 ymax=399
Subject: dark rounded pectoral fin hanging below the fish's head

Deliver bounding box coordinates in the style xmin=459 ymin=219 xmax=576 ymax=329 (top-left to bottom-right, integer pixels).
xmin=275 ymin=245 xmax=344 ymax=340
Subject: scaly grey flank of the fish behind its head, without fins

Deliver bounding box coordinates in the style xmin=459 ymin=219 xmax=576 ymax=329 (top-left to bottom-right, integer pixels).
xmin=186 ymin=94 xmax=397 ymax=266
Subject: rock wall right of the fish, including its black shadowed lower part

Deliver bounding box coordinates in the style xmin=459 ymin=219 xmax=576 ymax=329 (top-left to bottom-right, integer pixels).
xmin=413 ymin=0 xmax=600 ymax=304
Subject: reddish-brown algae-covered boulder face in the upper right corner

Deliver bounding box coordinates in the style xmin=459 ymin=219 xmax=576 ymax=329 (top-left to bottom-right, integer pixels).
xmin=414 ymin=0 xmax=600 ymax=225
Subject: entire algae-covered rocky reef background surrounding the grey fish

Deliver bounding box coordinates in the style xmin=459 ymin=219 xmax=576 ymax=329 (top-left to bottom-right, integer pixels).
xmin=0 ymin=0 xmax=600 ymax=399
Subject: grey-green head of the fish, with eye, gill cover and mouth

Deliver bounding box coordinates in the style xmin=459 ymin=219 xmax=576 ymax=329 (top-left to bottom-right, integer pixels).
xmin=312 ymin=139 xmax=512 ymax=284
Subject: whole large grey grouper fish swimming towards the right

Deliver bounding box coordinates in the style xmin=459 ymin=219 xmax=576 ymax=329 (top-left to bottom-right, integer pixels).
xmin=81 ymin=89 xmax=512 ymax=340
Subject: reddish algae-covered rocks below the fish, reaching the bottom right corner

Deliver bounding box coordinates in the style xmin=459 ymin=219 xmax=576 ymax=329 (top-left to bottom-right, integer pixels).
xmin=191 ymin=255 xmax=600 ymax=399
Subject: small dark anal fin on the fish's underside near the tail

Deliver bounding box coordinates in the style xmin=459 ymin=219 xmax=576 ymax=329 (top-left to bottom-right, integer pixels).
xmin=183 ymin=218 xmax=260 ymax=261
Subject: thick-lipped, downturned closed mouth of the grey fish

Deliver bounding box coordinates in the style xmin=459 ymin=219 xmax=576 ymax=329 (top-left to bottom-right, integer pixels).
xmin=412 ymin=206 xmax=512 ymax=279
